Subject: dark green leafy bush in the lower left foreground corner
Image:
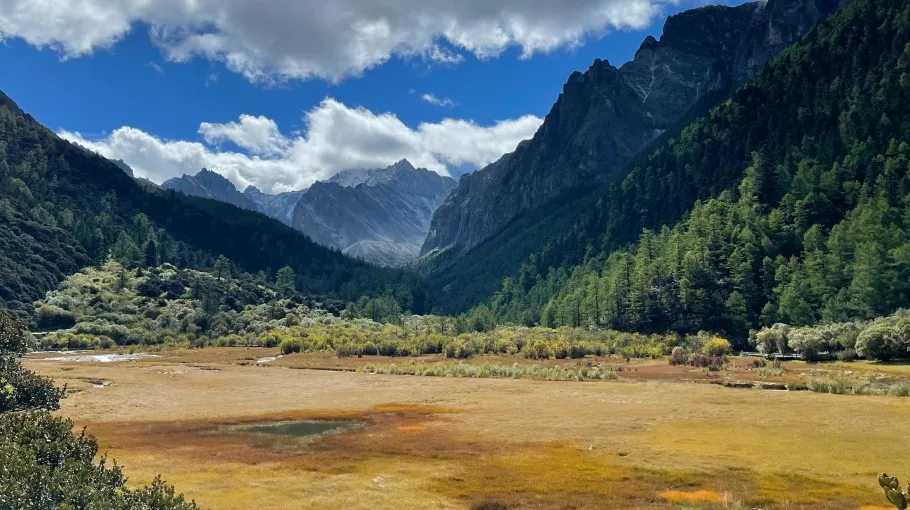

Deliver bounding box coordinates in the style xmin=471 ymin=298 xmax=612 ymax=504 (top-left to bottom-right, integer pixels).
xmin=0 ymin=313 xmax=196 ymax=510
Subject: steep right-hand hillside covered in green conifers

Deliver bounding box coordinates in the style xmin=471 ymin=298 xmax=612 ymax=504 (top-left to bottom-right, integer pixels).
xmin=492 ymin=0 xmax=910 ymax=339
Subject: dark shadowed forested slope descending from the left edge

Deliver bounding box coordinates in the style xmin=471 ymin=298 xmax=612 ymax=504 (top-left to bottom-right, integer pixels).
xmin=0 ymin=93 xmax=425 ymax=315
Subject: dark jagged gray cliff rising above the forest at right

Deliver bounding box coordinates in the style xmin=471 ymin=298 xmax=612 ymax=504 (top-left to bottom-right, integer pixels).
xmin=421 ymin=0 xmax=844 ymax=255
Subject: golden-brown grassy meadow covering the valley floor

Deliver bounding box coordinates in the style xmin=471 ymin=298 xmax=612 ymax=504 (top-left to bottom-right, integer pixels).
xmin=26 ymin=349 xmax=910 ymax=510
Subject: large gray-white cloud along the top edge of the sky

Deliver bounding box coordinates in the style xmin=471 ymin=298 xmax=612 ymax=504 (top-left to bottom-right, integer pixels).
xmin=0 ymin=0 xmax=675 ymax=81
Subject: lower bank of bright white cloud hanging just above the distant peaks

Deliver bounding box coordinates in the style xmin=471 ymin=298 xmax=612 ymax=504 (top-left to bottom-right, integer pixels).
xmin=60 ymin=99 xmax=543 ymax=192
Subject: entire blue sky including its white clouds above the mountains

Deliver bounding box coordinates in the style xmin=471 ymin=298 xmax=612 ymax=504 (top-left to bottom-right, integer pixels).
xmin=0 ymin=0 xmax=736 ymax=191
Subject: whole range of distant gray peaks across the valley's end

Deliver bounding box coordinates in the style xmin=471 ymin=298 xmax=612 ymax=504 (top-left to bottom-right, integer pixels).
xmin=161 ymin=160 xmax=455 ymax=266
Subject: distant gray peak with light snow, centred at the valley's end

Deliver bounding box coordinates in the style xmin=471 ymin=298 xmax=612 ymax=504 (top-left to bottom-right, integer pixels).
xmin=291 ymin=160 xmax=455 ymax=265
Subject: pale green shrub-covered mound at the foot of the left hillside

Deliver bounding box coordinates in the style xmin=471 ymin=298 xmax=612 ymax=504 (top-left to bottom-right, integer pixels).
xmin=35 ymin=259 xmax=345 ymax=349
